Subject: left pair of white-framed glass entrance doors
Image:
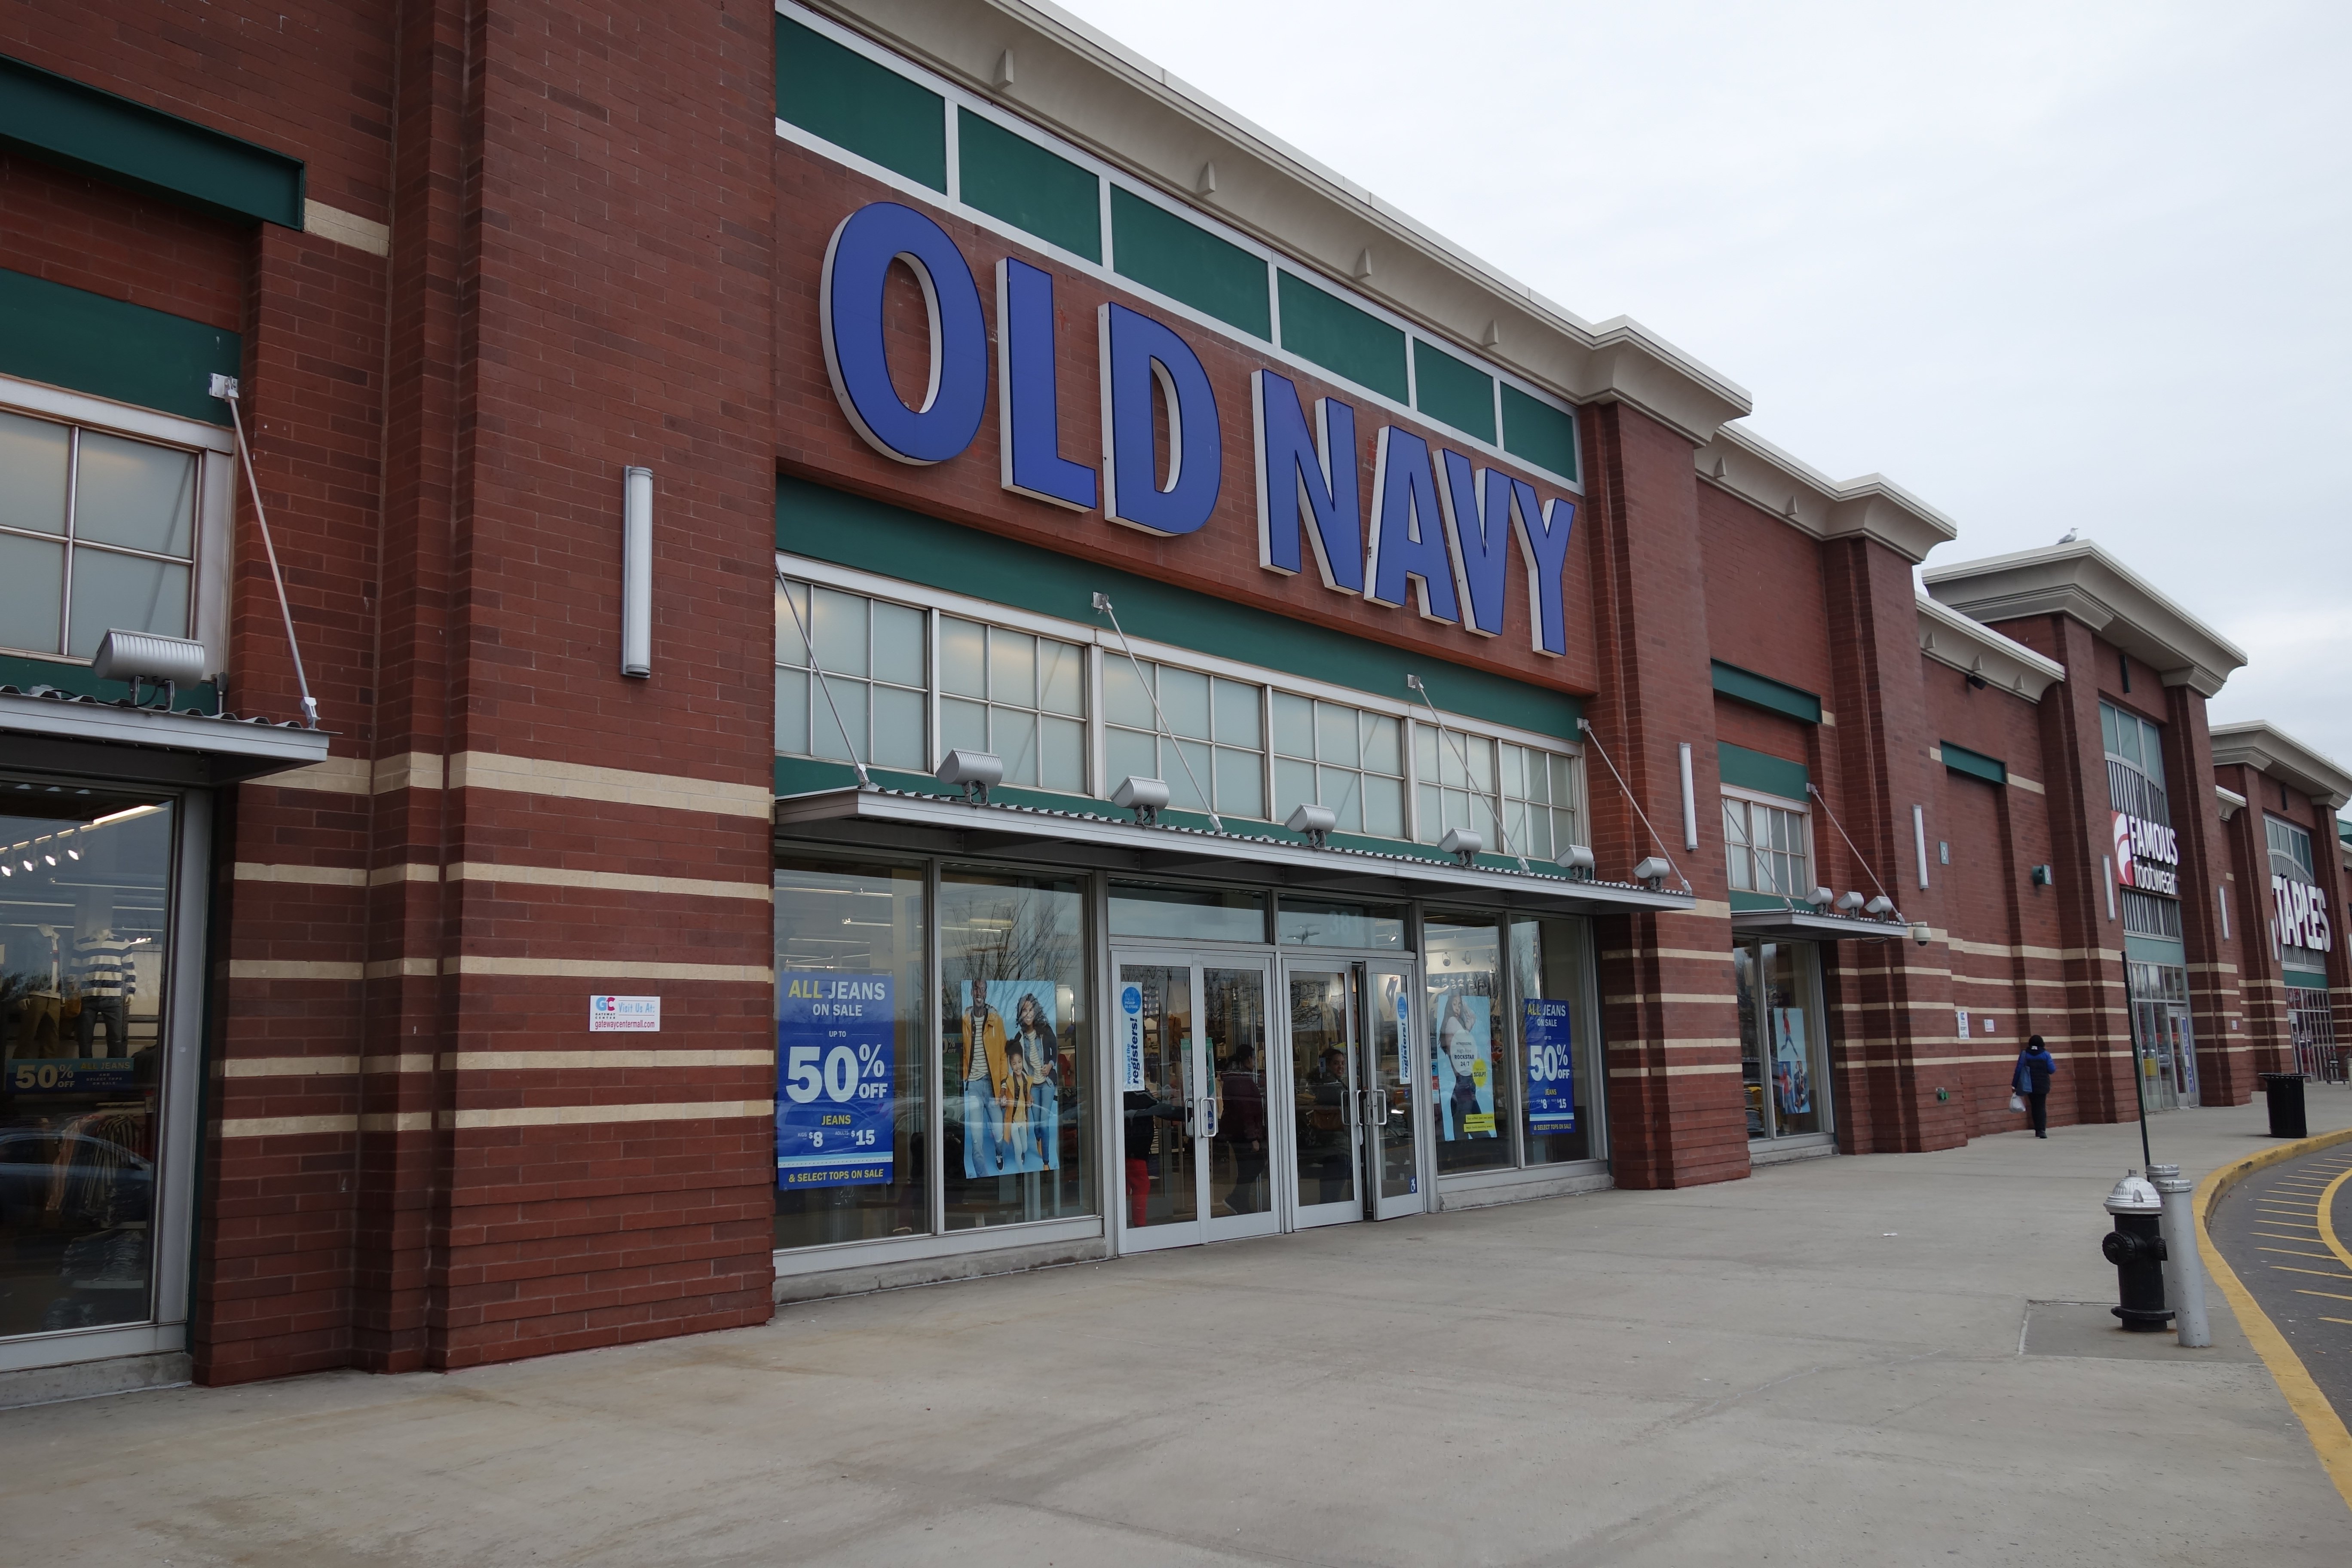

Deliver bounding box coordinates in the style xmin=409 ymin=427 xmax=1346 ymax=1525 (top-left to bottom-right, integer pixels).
xmin=1112 ymin=952 xmax=1277 ymax=1251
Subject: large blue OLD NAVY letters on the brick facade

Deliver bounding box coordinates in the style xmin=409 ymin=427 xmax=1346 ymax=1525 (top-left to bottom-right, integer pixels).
xmin=818 ymin=202 xmax=1576 ymax=656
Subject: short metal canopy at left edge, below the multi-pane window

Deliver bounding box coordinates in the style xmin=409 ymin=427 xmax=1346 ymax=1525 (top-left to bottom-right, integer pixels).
xmin=0 ymin=689 xmax=329 ymax=785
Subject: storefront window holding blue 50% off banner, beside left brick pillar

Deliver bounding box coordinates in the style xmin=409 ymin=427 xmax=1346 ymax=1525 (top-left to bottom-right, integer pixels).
xmin=776 ymin=861 xmax=929 ymax=1246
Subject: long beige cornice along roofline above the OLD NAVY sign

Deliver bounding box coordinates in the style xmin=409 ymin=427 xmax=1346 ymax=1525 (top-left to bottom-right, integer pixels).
xmin=807 ymin=0 xmax=1752 ymax=442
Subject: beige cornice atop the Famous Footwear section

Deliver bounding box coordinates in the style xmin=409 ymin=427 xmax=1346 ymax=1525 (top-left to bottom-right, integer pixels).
xmin=1919 ymin=538 xmax=2246 ymax=696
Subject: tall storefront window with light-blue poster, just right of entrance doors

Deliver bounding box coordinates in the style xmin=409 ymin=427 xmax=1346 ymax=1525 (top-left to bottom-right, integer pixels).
xmin=1421 ymin=917 xmax=1517 ymax=1176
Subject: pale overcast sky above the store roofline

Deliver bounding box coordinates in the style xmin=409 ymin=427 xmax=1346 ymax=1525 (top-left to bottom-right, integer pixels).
xmin=1061 ymin=0 xmax=2352 ymax=804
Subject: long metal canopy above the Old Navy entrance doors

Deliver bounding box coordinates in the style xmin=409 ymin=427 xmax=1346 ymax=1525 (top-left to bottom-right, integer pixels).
xmin=776 ymin=787 xmax=1698 ymax=915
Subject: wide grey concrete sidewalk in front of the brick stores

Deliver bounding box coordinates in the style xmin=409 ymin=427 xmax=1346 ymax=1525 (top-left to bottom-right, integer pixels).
xmin=0 ymin=1086 xmax=2352 ymax=1568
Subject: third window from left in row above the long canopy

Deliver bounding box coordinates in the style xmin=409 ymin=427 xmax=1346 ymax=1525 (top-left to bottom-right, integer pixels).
xmin=1103 ymin=656 xmax=1265 ymax=821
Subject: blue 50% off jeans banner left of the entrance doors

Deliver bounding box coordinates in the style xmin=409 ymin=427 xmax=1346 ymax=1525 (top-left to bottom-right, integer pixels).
xmin=776 ymin=971 xmax=896 ymax=1187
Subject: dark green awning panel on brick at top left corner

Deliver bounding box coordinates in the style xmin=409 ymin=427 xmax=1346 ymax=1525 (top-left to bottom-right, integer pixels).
xmin=0 ymin=54 xmax=303 ymax=228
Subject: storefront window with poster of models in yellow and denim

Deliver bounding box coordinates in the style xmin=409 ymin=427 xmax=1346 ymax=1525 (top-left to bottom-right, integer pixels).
xmin=938 ymin=872 xmax=1093 ymax=1229
